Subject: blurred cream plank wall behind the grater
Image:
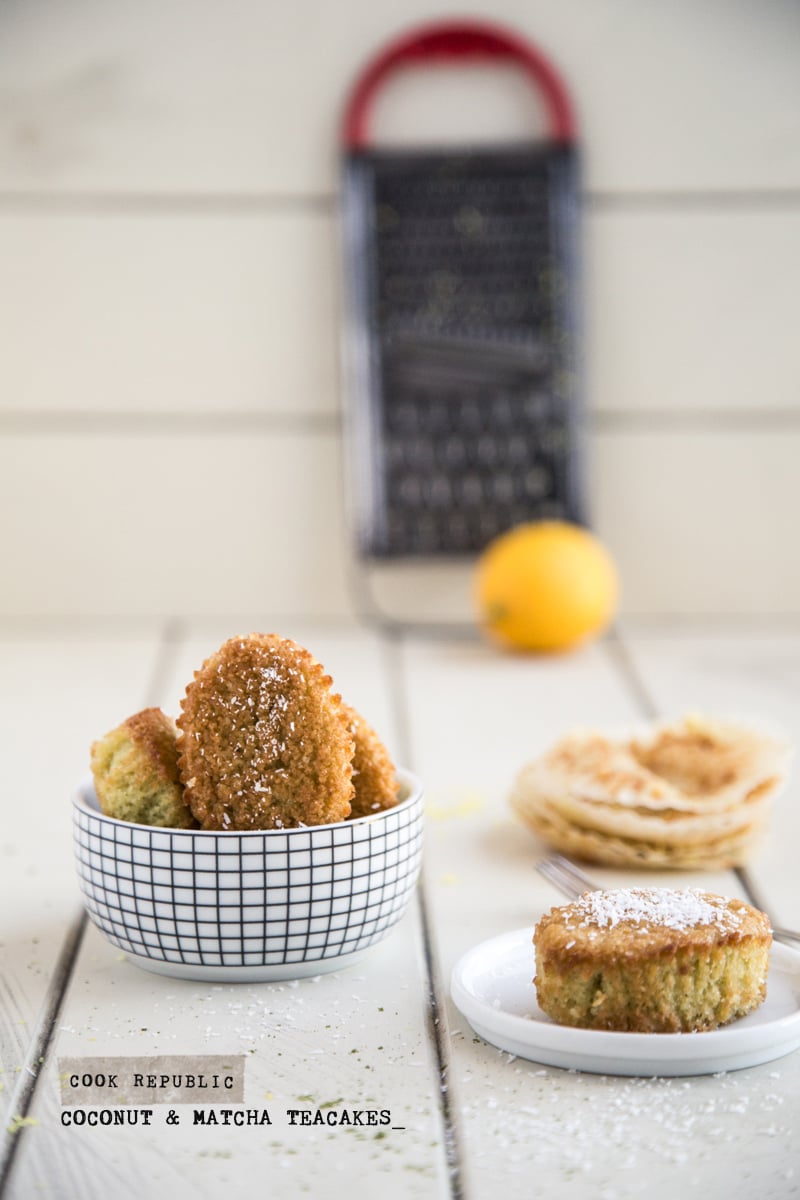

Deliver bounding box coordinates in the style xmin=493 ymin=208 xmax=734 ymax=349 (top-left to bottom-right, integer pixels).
xmin=0 ymin=0 xmax=800 ymax=617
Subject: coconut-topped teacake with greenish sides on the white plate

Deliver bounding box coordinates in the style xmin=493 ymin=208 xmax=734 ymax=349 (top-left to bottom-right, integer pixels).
xmin=534 ymin=888 xmax=772 ymax=1033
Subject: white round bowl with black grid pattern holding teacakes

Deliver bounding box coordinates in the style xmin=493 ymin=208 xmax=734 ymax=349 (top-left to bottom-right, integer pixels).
xmin=73 ymin=770 xmax=423 ymax=982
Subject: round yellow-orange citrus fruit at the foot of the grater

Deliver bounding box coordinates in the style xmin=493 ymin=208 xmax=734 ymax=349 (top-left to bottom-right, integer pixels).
xmin=475 ymin=521 xmax=619 ymax=650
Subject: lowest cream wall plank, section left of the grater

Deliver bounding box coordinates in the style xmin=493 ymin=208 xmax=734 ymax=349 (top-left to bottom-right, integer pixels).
xmin=0 ymin=427 xmax=348 ymax=617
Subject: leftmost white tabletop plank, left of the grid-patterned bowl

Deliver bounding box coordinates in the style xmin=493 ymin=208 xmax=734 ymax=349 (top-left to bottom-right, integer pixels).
xmin=0 ymin=624 xmax=160 ymax=1130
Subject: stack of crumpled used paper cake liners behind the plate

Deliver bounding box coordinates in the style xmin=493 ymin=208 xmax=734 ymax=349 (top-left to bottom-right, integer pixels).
xmin=511 ymin=716 xmax=790 ymax=869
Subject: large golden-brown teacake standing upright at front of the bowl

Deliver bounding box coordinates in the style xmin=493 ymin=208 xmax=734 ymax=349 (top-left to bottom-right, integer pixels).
xmin=178 ymin=634 xmax=355 ymax=829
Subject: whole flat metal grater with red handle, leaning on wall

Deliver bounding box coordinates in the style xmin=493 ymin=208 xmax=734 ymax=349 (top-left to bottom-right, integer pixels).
xmin=343 ymin=22 xmax=583 ymax=628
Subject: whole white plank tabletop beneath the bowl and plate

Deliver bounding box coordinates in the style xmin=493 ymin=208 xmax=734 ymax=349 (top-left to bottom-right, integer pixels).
xmin=0 ymin=618 xmax=800 ymax=1200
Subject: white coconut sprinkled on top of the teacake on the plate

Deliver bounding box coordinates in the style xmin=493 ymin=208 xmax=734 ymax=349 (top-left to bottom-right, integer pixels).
xmin=563 ymin=888 xmax=740 ymax=930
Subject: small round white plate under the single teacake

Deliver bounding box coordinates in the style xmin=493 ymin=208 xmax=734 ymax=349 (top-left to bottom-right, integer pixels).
xmin=451 ymin=929 xmax=800 ymax=1075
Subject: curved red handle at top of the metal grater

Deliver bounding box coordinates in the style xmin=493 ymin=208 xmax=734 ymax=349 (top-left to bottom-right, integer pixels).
xmin=343 ymin=22 xmax=576 ymax=150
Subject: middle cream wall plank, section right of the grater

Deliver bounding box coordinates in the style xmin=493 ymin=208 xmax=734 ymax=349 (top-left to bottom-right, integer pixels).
xmin=585 ymin=208 xmax=800 ymax=424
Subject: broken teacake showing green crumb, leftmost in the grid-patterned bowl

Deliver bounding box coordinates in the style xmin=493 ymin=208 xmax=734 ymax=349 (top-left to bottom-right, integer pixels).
xmin=91 ymin=708 xmax=196 ymax=829
